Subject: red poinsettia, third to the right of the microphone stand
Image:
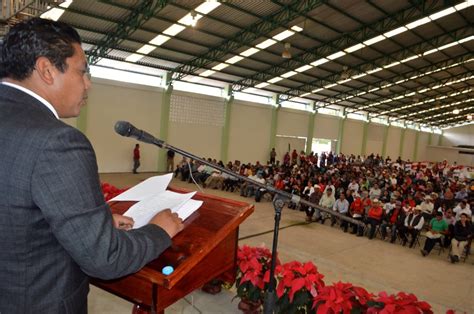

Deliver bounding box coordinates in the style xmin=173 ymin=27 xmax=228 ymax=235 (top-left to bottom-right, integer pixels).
xmin=367 ymin=291 xmax=433 ymax=314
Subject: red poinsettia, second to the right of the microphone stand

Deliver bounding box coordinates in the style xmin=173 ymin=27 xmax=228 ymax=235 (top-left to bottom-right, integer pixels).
xmin=313 ymin=282 xmax=373 ymax=314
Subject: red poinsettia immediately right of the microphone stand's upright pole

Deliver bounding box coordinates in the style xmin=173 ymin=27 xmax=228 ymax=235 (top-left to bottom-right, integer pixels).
xmin=265 ymin=261 xmax=324 ymax=313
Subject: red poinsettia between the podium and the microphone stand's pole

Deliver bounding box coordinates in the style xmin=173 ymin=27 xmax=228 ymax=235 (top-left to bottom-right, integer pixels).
xmin=236 ymin=245 xmax=279 ymax=308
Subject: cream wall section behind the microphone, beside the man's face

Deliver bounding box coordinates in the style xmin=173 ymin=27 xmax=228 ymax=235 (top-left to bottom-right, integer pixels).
xmin=85 ymin=79 xmax=161 ymax=172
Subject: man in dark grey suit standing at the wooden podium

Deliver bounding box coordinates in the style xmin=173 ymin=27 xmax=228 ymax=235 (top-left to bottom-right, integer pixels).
xmin=0 ymin=18 xmax=183 ymax=314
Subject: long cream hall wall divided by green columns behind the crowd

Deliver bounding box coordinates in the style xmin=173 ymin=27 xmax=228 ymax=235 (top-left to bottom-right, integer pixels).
xmin=78 ymin=78 xmax=474 ymax=172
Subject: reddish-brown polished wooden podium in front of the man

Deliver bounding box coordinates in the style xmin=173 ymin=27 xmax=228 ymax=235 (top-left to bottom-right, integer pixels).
xmin=91 ymin=188 xmax=254 ymax=313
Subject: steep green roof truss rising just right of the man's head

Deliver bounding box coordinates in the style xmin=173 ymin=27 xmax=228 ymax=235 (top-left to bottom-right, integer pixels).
xmin=89 ymin=0 xmax=167 ymax=64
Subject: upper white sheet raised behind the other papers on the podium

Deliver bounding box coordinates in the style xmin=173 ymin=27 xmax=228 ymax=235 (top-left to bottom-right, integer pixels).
xmin=109 ymin=173 xmax=173 ymax=202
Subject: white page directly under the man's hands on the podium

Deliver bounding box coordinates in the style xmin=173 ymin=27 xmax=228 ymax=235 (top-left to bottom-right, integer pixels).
xmin=124 ymin=191 xmax=196 ymax=229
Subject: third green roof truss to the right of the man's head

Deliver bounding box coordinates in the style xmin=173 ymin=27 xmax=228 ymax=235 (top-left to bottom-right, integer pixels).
xmin=232 ymin=0 xmax=460 ymax=94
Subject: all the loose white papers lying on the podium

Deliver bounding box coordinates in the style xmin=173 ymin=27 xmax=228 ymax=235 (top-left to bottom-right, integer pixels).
xmin=110 ymin=173 xmax=203 ymax=229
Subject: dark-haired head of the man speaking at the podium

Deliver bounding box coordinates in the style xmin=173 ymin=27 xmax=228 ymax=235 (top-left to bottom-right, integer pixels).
xmin=0 ymin=18 xmax=90 ymax=118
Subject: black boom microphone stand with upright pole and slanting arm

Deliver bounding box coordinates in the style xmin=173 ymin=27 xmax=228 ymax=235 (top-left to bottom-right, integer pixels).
xmin=137 ymin=138 xmax=363 ymax=314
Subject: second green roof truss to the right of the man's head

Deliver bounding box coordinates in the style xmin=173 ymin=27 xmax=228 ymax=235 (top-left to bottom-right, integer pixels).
xmin=168 ymin=0 xmax=326 ymax=80
